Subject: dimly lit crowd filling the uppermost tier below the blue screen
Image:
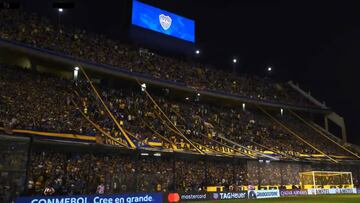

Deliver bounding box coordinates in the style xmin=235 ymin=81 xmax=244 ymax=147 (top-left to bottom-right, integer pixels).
xmin=0 ymin=10 xmax=314 ymax=106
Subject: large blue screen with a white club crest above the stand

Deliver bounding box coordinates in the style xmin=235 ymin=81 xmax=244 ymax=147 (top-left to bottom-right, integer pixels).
xmin=131 ymin=0 xmax=195 ymax=42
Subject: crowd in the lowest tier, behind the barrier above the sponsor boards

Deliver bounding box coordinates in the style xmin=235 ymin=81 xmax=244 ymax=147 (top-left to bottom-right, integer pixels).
xmin=22 ymin=150 xmax=359 ymax=195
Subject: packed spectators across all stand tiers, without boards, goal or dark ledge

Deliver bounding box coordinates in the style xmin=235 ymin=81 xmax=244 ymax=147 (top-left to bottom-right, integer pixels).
xmin=0 ymin=7 xmax=360 ymax=202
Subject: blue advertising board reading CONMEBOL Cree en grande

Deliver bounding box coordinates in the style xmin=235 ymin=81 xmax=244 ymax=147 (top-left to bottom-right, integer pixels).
xmin=15 ymin=193 xmax=163 ymax=203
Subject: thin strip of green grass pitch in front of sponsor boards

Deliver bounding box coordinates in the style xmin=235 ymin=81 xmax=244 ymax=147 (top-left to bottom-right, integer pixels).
xmin=194 ymin=195 xmax=360 ymax=203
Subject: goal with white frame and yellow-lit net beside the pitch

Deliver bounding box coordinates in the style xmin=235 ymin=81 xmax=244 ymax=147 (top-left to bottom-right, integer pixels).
xmin=299 ymin=171 xmax=354 ymax=194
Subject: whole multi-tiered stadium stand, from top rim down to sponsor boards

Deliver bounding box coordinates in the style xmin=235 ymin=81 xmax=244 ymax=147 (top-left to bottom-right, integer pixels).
xmin=0 ymin=1 xmax=360 ymax=203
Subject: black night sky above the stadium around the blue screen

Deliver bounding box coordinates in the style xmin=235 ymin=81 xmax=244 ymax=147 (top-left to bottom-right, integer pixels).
xmin=20 ymin=0 xmax=360 ymax=144
